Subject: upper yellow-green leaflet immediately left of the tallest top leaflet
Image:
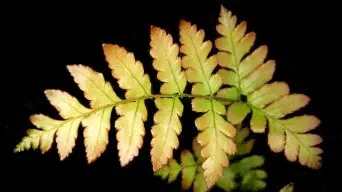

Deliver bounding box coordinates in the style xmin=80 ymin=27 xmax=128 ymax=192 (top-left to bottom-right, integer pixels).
xmin=180 ymin=20 xmax=222 ymax=95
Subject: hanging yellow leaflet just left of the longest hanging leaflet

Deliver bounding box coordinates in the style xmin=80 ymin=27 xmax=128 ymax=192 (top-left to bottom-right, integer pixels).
xmin=151 ymin=98 xmax=183 ymax=170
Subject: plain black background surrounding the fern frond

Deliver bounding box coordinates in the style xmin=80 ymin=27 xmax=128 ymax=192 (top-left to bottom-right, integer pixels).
xmin=0 ymin=0 xmax=342 ymax=191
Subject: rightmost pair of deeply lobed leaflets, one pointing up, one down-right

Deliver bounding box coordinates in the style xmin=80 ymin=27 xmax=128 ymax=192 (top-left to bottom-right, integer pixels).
xmin=215 ymin=7 xmax=322 ymax=168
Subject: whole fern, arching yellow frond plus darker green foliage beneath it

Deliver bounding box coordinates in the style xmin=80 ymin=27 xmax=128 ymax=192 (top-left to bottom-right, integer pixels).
xmin=14 ymin=4 xmax=323 ymax=191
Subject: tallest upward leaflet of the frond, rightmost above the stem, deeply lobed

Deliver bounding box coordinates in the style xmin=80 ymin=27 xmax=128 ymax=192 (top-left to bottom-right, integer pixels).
xmin=215 ymin=7 xmax=275 ymax=95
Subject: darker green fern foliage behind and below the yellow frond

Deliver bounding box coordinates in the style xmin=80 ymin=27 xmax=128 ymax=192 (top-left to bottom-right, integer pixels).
xmin=157 ymin=128 xmax=267 ymax=191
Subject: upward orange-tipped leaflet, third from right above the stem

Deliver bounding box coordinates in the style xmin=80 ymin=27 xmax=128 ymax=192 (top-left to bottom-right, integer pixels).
xmin=150 ymin=26 xmax=186 ymax=94
